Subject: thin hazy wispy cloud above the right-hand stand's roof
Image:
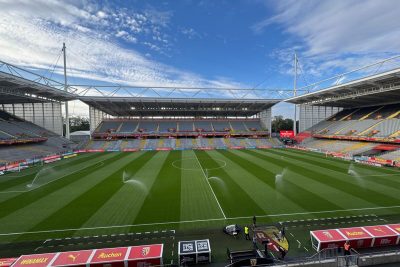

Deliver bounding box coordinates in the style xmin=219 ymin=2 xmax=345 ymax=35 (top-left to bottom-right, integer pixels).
xmin=255 ymin=0 xmax=400 ymax=86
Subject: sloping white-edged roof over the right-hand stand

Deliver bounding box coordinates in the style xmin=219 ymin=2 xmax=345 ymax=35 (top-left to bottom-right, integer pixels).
xmin=285 ymin=69 xmax=400 ymax=108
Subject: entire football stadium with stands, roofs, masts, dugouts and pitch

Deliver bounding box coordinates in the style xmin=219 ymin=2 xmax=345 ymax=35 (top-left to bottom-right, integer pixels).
xmin=0 ymin=1 xmax=400 ymax=267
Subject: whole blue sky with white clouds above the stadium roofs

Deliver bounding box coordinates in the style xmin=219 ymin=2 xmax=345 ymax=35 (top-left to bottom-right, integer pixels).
xmin=0 ymin=0 xmax=400 ymax=116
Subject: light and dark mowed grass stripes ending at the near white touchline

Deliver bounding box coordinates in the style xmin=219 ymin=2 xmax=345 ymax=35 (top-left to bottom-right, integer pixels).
xmin=0 ymin=149 xmax=400 ymax=244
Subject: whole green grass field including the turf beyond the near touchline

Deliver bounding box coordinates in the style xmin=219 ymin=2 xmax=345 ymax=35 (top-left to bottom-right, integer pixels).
xmin=0 ymin=149 xmax=400 ymax=259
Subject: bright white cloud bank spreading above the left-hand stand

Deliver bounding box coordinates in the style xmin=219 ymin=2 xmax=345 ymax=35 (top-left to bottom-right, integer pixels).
xmin=0 ymin=0 xmax=250 ymax=107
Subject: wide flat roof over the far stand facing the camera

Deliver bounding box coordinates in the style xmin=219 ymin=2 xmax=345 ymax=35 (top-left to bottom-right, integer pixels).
xmin=79 ymin=96 xmax=280 ymax=117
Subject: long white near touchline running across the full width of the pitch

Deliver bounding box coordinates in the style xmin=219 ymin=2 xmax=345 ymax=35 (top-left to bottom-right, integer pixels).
xmin=0 ymin=206 xmax=400 ymax=236
